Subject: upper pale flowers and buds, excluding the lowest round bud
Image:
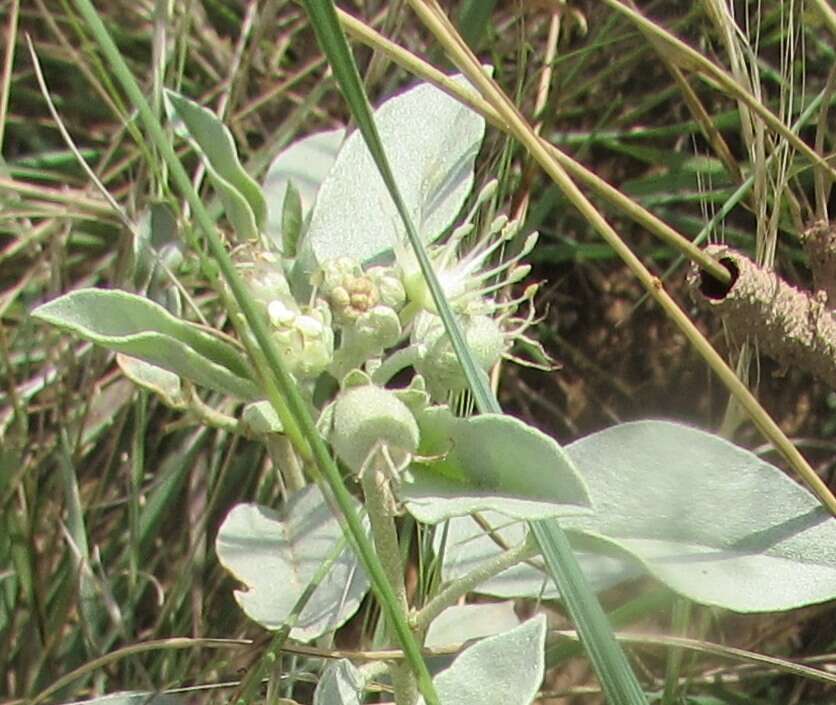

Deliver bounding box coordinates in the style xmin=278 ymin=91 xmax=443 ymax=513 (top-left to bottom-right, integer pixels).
xmin=240 ymin=176 xmax=537 ymax=403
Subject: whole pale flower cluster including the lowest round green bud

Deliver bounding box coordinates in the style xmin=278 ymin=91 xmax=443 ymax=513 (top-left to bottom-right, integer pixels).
xmin=241 ymin=176 xmax=537 ymax=482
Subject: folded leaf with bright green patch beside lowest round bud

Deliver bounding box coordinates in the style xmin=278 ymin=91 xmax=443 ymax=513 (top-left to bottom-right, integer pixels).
xmin=400 ymin=407 xmax=589 ymax=524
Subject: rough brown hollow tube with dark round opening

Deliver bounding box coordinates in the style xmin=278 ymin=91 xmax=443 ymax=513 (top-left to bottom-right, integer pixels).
xmin=688 ymin=245 xmax=836 ymax=389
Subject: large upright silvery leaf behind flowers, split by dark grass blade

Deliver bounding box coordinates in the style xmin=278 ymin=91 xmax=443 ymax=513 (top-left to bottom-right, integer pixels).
xmin=302 ymin=76 xmax=485 ymax=270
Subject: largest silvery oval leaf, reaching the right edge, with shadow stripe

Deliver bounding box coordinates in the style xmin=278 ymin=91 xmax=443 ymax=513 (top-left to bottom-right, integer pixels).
xmin=565 ymin=421 xmax=836 ymax=612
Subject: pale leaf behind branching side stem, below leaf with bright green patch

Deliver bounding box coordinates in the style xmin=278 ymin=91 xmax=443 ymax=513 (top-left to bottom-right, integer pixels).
xmin=435 ymin=512 xmax=643 ymax=600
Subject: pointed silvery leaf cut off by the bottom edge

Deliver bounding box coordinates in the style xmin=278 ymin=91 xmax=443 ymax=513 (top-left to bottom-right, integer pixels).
xmin=418 ymin=614 xmax=546 ymax=705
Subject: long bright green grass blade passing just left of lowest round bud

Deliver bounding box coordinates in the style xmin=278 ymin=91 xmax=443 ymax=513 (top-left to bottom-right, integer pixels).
xmin=69 ymin=0 xmax=438 ymax=705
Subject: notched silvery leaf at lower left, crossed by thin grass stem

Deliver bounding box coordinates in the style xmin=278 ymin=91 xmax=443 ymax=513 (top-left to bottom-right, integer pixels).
xmin=215 ymin=485 xmax=369 ymax=641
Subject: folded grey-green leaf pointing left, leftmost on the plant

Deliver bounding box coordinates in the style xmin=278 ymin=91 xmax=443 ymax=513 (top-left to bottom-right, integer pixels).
xmin=32 ymin=289 xmax=260 ymax=399
